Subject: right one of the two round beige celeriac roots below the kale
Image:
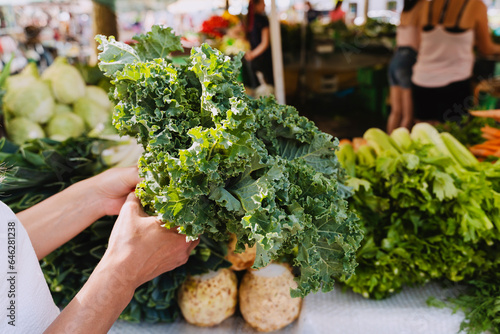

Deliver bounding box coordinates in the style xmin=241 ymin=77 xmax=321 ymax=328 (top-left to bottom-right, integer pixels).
xmin=239 ymin=263 xmax=302 ymax=332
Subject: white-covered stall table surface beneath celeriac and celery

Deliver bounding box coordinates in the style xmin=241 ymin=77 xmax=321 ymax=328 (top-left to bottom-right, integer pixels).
xmin=109 ymin=283 xmax=464 ymax=334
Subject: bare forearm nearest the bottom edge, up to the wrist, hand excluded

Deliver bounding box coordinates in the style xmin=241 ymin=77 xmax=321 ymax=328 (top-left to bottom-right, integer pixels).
xmin=44 ymin=262 xmax=134 ymax=334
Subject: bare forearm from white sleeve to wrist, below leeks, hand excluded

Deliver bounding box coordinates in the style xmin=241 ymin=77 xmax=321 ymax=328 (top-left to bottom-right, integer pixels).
xmin=17 ymin=180 xmax=104 ymax=259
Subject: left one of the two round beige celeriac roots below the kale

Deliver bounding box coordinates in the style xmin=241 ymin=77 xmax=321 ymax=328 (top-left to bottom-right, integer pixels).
xmin=178 ymin=269 xmax=238 ymax=327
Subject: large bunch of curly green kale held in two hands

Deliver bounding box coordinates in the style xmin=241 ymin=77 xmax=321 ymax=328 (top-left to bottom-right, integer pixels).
xmin=96 ymin=26 xmax=362 ymax=296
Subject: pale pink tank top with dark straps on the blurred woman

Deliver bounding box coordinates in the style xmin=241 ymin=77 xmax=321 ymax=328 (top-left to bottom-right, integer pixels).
xmin=412 ymin=1 xmax=474 ymax=88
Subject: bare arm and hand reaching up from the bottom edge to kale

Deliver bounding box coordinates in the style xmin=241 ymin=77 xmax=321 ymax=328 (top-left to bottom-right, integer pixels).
xmin=45 ymin=193 xmax=198 ymax=334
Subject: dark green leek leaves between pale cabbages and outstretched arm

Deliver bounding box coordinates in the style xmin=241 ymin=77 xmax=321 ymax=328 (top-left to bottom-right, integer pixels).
xmin=0 ymin=137 xmax=115 ymax=212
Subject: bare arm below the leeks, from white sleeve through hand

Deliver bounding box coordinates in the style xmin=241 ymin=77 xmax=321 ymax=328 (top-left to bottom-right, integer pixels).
xmin=17 ymin=167 xmax=139 ymax=260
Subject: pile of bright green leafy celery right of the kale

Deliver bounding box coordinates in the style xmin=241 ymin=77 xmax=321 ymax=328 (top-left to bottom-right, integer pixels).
xmin=339 ymin=123 xmax=500 ymax=299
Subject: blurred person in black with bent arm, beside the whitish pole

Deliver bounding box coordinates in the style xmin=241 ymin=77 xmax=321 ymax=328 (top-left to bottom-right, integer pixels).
xmin=245 ymin=0 xmax=274 ymax=88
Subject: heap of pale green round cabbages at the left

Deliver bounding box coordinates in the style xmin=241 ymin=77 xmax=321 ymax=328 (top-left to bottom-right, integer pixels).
xmin=3 ymin=58 xmax=116 ymax=145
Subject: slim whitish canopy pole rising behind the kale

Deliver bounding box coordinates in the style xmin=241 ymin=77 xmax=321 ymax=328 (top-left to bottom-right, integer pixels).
xmin=269 ymin=0 xmax=285 ymax=104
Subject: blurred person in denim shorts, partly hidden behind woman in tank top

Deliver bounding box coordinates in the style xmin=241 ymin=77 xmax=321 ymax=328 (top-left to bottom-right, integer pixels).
xmin=387 ymin=0 xmax=423 ymax=134
